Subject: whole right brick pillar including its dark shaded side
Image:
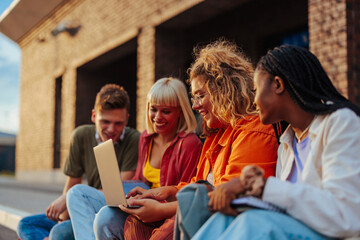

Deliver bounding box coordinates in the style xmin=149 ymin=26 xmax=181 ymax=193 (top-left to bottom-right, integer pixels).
xmin=309 ymin=0 xmax=360 ymax=105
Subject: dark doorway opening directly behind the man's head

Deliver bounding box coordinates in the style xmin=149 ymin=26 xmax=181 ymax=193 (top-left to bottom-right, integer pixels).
xmin=75 ymin=39 xmax=137 ymax=128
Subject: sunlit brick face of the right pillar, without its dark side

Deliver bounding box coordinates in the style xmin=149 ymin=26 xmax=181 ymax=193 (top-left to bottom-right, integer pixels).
xmin=309 ymin=0 xmax=348 ymax=96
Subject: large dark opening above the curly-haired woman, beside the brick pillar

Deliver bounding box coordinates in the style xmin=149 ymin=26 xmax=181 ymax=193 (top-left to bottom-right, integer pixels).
xmin=155 ymin=0 xmax=308 ymax=79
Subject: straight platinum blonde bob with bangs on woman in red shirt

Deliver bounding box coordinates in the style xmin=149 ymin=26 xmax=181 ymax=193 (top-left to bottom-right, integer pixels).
xmin=146 ymin=77 xmax=196 ymax=133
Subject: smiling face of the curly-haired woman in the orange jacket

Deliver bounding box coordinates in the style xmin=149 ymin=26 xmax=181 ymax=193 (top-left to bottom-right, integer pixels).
xmin=191 ymin=76 xmax=227 ymax=129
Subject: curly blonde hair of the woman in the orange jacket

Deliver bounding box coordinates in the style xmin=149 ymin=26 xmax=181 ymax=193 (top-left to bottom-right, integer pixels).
xmin=188 ymin=39 xmax=256 ymax=135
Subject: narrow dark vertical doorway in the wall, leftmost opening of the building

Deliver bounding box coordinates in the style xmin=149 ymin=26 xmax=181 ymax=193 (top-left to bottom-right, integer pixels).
xmin=53 ymin=76 xmax=62 ymax=168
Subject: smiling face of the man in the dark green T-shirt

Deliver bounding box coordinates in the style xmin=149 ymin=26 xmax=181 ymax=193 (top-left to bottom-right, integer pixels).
xmin=91 ymin=108 xmax=129 ymax=142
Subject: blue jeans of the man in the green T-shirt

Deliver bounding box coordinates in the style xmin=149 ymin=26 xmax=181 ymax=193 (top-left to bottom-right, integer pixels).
xmin=17 ymin=214 xmax=75 ymax=240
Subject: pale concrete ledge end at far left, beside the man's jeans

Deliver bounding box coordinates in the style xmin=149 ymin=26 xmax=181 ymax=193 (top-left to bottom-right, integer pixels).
xmin=0 ymin=205 xmax=30 ymax=231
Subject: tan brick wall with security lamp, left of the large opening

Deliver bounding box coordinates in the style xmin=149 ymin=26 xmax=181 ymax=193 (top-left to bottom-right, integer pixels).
xmin=16 ymin=0 xmax=201 ymax=172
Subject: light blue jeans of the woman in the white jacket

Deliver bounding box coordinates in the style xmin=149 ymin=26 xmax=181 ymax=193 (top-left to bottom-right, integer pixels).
xmin=192 ymin=209 xmax=332 ymax=240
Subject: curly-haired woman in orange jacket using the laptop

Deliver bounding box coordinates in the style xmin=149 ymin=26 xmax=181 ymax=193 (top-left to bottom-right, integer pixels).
xmin=116 ymin=40 xmax=278 ymax=239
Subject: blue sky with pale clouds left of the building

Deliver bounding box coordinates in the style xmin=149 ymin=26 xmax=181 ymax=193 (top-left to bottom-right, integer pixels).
xmin=0 ymin=0 xmax=21 ymax=134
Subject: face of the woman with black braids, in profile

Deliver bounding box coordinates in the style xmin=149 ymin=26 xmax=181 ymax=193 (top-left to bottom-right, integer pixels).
xmin=254 ymin=70 xmax=283 ymax=124
